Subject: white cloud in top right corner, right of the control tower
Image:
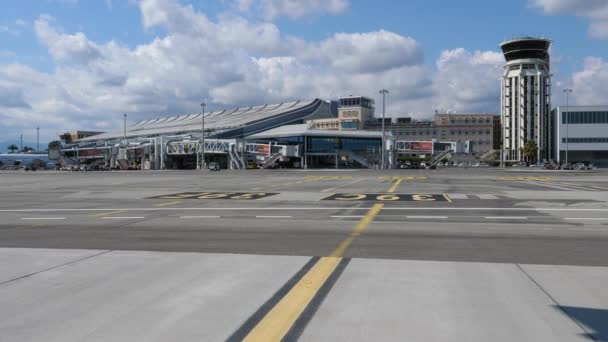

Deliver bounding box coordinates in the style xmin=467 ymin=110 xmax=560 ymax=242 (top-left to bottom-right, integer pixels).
xmin=529 ymin=0 xmax=608 ymax=39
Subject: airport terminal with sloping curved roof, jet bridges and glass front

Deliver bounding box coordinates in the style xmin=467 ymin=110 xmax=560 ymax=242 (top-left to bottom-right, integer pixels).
xmin=61 ymin=99 xmax=394 ymax=169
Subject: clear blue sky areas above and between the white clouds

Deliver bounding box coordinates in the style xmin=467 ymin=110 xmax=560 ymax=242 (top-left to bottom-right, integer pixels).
xmin=0 ymin=0 xmax=608 ymax=72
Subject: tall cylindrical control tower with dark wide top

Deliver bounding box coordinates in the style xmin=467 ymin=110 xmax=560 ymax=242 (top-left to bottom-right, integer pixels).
xmin=500 ymin=37 xmax=551 ymax=161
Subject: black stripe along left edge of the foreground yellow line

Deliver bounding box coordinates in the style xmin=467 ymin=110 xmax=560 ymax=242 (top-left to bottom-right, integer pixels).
xmin=226 ymin=257 xmax=320 ymax=342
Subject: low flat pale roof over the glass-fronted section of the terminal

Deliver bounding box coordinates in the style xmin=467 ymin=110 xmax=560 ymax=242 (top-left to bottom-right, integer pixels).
xmin=247 ymin=124 xmax=384 ymax=140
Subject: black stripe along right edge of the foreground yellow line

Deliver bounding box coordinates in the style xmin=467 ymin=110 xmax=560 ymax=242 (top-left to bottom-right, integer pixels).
xmin=283 ymin=258 xmax=350 ymax=341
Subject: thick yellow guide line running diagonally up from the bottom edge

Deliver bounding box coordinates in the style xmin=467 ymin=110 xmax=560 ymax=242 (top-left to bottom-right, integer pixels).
xmin=243 ymin=204 xmax=384 ymax=342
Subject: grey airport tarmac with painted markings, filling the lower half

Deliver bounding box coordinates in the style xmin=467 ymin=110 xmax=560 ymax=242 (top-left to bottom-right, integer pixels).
xmin=0 ymin=169 xmax=608 ymax=341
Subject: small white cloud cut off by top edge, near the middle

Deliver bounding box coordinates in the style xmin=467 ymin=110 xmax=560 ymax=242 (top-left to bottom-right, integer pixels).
xmin=236 ymin=0 xmax=350 ymax=20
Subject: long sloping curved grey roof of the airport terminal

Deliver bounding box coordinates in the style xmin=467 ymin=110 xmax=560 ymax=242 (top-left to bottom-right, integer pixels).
xmin=80 ymin=99 xmax=333 ymax=142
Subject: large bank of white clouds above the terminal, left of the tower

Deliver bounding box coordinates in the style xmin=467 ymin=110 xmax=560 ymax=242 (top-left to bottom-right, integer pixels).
xmin=0 ymin=0 xmax=502 ymax=143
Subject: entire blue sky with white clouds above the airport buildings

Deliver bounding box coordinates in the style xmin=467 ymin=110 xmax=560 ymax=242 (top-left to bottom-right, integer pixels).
xmin=0 ymin=0 xmax=608 ymax=148
